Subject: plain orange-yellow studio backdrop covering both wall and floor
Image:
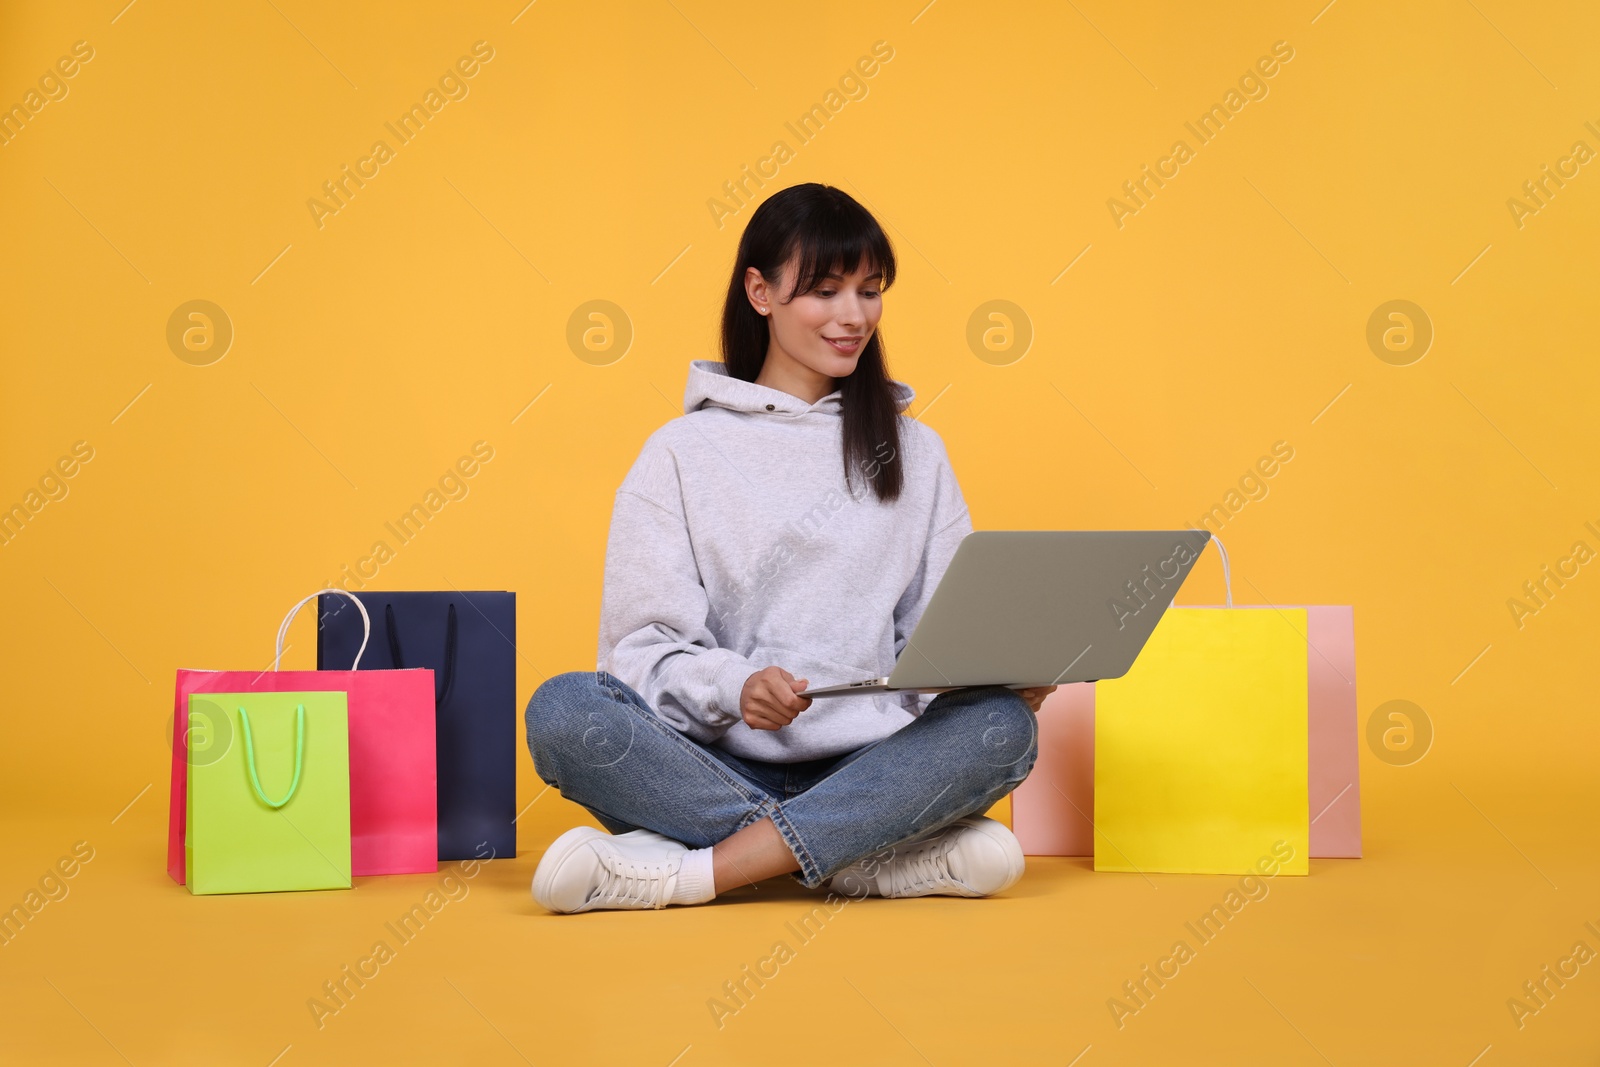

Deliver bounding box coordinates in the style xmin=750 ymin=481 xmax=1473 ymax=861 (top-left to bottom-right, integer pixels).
xmin=0 ymin=0 xmax=1600 ymax=1067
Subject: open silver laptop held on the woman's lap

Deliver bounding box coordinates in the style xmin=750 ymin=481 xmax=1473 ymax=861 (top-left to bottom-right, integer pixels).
xmin=798 ymin=530 xmax=1211 ymax=697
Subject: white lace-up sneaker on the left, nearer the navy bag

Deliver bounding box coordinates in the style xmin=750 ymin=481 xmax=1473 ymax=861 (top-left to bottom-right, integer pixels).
xmin=533 ymin=825 xmax=688 ymax=912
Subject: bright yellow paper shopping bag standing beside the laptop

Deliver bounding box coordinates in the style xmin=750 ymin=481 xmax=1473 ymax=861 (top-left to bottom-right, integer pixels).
xmin=1094 ymin=534 xmax=1310 ymax=875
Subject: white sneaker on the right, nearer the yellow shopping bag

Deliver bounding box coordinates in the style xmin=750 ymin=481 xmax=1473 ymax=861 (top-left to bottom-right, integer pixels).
xmin=827 ymin=816 xmax=1024 ymax=897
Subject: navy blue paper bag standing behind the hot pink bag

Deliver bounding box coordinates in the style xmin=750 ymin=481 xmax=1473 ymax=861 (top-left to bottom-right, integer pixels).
xmin=317 ymin=592 xmax=517 ymax=861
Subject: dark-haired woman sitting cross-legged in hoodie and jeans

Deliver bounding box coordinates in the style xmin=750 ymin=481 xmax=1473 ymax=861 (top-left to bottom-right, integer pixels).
xmin=528 ymin=184 xmax=1054 ymax=912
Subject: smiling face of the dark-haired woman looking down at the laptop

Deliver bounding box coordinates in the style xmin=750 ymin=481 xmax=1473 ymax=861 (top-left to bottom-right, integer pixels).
xmin=744 ymin=259 xmax=883 ymax=378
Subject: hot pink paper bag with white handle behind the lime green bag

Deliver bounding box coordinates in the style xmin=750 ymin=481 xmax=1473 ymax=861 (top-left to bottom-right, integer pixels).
xmin=166 ymin=590 xmax=438 ymax=885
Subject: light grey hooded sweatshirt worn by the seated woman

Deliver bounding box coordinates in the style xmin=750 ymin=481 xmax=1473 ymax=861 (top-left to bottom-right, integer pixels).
xmin=598 ymin=360 xmax=973 ymax=763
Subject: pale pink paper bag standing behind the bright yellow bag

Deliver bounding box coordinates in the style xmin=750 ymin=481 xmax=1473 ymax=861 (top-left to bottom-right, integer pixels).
xmin=1011 ymin=536 xmax=1362 ymax=859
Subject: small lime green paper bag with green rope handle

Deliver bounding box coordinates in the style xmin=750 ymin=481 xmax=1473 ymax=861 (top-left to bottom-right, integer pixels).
xmin=184 ymin=693 xmax=350 ymax=894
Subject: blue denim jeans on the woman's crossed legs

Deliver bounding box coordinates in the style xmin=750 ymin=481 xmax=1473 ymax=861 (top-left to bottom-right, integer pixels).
xmin=526 ymin=670 xmax=1038 ymax=888
